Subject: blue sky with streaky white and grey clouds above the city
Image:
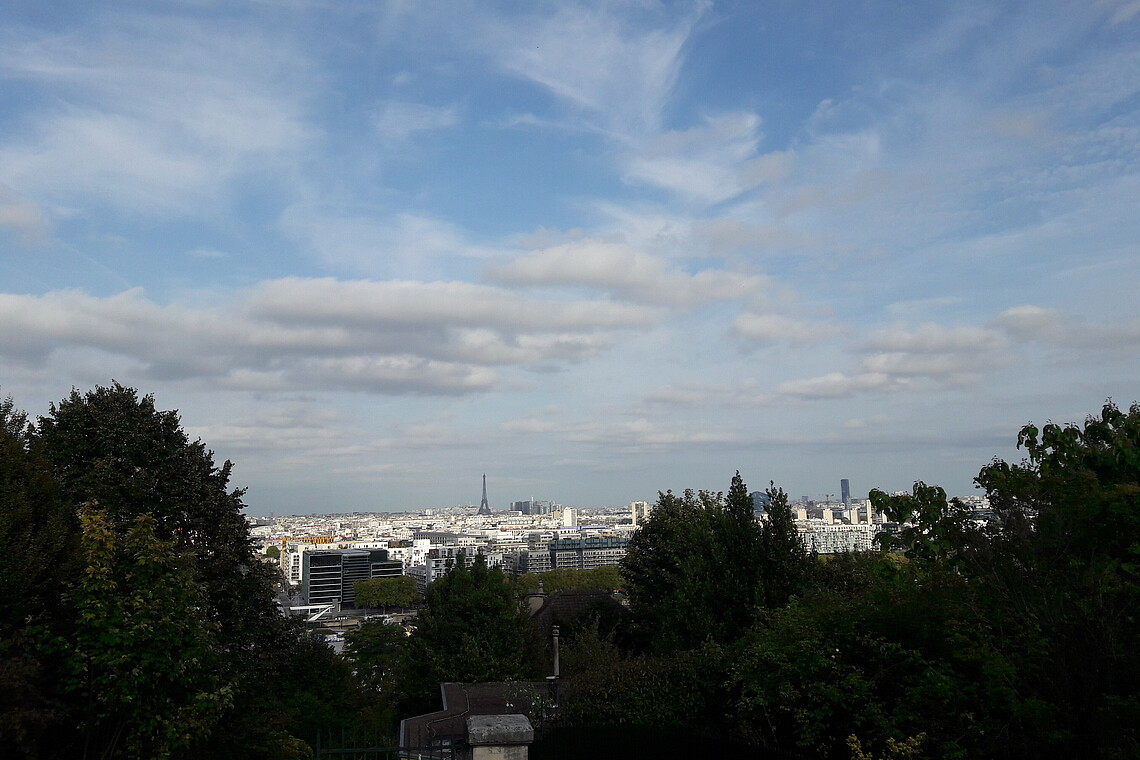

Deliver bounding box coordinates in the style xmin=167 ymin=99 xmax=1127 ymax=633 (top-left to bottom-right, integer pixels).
xmin=0 ymin=0 xmax=1140 ymax=515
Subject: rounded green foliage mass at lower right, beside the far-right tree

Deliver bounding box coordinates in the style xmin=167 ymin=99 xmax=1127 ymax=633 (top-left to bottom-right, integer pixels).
xmin=733 ymin=554 xmax=1016 ymax=758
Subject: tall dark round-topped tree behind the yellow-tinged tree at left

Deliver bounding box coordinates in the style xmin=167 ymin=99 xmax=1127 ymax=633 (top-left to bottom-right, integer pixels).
xmin=33 ymin=383 xmax=337 ymax=758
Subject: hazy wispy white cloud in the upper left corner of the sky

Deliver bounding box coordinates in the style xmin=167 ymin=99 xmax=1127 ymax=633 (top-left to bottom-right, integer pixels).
xmin=0 ymin=14 xmax=311 ymax=215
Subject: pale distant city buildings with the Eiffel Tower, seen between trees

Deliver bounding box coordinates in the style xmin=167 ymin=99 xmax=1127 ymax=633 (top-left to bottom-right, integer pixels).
xmin=251 ymin=475 xmax=988 ymax=611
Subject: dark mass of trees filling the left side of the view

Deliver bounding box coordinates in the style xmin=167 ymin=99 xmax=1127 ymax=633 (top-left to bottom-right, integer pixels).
xmin=0 ymin=384 xmax=371 ymax=759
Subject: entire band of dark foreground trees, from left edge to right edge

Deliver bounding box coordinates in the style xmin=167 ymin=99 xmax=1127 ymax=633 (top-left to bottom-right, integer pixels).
xmin=0 ymin=385 xmax=1140 ymax=760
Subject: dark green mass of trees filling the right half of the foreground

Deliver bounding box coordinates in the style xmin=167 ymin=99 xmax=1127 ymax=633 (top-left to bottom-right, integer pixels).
xmin=554 ymin=403 xmax=1140 ymax=760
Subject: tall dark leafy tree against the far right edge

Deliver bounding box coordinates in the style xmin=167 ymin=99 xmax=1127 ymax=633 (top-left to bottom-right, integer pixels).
xmin=972 ymin=401 xmax=1140 ymax=757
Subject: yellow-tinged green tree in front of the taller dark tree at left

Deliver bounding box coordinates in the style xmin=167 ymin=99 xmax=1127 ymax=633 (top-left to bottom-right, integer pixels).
xmin=65 ymin=508 xmax=230 ymax=759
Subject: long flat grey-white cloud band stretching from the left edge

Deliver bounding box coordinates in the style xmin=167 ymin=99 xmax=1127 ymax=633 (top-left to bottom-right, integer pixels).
xmin=0 ymin=278 xmax=654 ymax=394
